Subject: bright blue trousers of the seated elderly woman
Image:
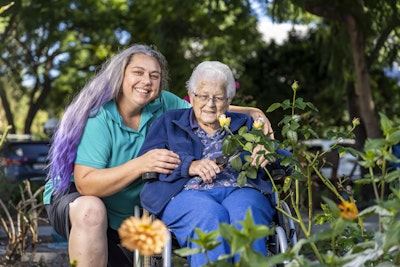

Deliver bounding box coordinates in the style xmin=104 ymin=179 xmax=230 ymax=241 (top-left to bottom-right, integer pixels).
xmin=160 ymin=187 xmax=275 ymax=267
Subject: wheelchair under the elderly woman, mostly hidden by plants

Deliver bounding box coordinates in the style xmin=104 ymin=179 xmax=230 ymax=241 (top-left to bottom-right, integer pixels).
xmin=134 ymin=193 xmax=297 ymax=267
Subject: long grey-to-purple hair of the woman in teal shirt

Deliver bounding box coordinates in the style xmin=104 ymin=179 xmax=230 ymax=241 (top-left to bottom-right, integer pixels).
xmin=48 ymin=44 xmax=168 ymax=193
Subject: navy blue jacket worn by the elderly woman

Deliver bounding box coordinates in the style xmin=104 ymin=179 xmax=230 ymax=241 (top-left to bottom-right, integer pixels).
xmin=139 ymin=108 xmax=290 ymax=215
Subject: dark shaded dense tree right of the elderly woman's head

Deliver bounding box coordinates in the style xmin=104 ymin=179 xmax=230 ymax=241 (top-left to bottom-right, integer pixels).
xmin=240 ymin=30 xmax=338 ymax=138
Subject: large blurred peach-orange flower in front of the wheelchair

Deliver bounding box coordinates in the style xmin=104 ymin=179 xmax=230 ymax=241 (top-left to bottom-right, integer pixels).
xmin=118 ymin=215 xmax=168 ymax=256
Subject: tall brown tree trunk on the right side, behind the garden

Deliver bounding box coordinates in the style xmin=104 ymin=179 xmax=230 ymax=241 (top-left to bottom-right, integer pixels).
xmin=344 ymin=15 xmax=382 ymax=141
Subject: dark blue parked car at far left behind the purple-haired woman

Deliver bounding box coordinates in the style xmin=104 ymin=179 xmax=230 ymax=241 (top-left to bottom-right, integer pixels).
xmin=0 ymin=137 xmax=49 ymax=184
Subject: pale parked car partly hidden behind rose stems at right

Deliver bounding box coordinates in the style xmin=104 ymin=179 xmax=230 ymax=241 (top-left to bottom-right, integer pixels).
xmin=304 ymin=139 xmax=361 ymax=180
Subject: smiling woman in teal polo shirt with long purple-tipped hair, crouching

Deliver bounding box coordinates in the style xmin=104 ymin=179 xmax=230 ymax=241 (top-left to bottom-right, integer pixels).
xmin=44 ymin=44 xmax=272 ymax=267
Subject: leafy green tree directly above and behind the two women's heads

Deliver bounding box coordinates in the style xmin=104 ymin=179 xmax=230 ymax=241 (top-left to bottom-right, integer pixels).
xmin=124 ymin=0 xmax=263 ymax=96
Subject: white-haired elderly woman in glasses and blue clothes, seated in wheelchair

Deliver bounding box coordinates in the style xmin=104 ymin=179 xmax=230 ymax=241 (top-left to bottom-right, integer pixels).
xmin=140 ymin=61 xmax=290 ymax=267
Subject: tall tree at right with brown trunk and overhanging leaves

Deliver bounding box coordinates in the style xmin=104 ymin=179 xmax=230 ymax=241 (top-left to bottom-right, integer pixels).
xmin=260 ymin=0 xmax=400 ymax=145
